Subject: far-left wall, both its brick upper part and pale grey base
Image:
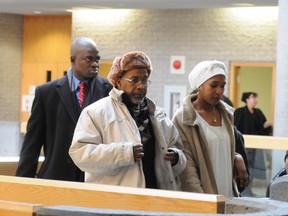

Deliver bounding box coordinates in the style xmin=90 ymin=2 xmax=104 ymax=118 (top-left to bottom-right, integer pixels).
xmin=0 ymin=13 xmax=23 ymax=156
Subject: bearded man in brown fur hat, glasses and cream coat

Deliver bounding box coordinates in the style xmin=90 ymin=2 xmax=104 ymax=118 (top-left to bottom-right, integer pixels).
xmin=69 ymin=51 xmax=186 ymax=190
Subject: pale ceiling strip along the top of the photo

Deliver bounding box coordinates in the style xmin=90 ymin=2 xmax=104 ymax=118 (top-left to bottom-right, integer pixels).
xmin=0 ymin=0 xmax=278 ymax=15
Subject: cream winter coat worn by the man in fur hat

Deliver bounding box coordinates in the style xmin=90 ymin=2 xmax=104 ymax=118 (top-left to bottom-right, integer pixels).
xmin=69 ymin=88 xmax=186 ymax=190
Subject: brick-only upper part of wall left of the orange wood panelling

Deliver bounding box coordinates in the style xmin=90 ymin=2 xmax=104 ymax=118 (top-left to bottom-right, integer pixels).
xmin=0 ymin=13 xmax=23 ymax=122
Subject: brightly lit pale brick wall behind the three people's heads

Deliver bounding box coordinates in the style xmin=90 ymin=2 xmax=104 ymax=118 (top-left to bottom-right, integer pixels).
xmin=72 ymin=8 xmax=277 ymax=106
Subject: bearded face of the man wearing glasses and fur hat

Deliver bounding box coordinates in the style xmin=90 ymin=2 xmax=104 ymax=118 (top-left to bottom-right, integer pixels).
xmin=116 ymin=68 xmax=149 ymax=105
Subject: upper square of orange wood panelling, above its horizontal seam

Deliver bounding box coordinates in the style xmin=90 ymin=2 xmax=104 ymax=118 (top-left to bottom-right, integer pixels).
xmin=23 ymin=16 xmax=71 ymax=62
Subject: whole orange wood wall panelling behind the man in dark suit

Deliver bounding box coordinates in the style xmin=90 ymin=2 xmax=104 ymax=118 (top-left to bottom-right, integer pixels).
xmin=20 ymin=16 xmax=71 ymax=122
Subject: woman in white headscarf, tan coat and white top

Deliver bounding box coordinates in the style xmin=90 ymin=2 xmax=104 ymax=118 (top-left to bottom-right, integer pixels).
xmin=172 ymin=60 xmax=249 ymax=197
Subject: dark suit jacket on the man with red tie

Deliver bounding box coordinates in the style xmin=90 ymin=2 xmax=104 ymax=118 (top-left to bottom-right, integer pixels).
xmin=16 ymin=72 xmax=112 ymax=181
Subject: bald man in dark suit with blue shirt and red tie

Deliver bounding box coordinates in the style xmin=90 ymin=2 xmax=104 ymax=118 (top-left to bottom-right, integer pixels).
xmin=16 ymin=38 xmax=112 ymax=181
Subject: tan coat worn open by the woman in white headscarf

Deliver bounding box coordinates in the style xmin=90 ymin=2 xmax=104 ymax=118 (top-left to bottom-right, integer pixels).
xmin=172 ymin=95 xmax=239 ymax=196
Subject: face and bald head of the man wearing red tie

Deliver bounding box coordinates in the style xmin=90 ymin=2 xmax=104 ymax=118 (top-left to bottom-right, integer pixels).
xmin=70 ymin=44 xmax=100 ymax=81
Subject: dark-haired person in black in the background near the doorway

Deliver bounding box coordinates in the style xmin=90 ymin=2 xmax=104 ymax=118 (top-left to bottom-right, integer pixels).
xmin=234 ymin=92 xmax=272 ymax=196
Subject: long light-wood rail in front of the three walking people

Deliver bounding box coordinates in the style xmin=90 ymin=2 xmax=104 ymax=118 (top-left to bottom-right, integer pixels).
xmin=0 ymin=176 xmax=226 ymax=214
